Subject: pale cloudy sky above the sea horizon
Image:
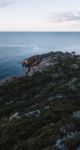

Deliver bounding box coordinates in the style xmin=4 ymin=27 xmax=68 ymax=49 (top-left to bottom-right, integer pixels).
xmin=0 ymin=0 xmax=80 ymax=31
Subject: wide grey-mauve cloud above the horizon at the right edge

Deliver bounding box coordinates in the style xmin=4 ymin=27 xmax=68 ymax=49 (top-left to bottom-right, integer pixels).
xmin=47 ymin=11 xmax=80 ymax=23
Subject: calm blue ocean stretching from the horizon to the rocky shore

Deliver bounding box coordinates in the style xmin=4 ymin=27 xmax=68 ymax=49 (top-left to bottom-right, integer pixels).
xmin=0 ymin=32 xmax=80 ymax=80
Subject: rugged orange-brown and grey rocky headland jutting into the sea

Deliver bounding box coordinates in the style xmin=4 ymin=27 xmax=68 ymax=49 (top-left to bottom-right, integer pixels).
xmin=22 ymin=52 xmax=75 ymax=76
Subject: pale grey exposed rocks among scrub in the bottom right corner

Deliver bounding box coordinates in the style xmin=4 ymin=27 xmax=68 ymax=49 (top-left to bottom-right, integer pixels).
xmin=56 ymin=123 xmax=80 ymax=150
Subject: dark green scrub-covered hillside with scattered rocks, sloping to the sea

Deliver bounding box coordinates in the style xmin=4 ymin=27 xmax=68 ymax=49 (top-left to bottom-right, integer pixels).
xmin=0 ymin=52 xmax=80 ymax=150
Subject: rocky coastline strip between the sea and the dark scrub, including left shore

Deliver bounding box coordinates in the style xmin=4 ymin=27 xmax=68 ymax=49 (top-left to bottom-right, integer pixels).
xmin=0 ymin=51 xmax=77 ymax=86
